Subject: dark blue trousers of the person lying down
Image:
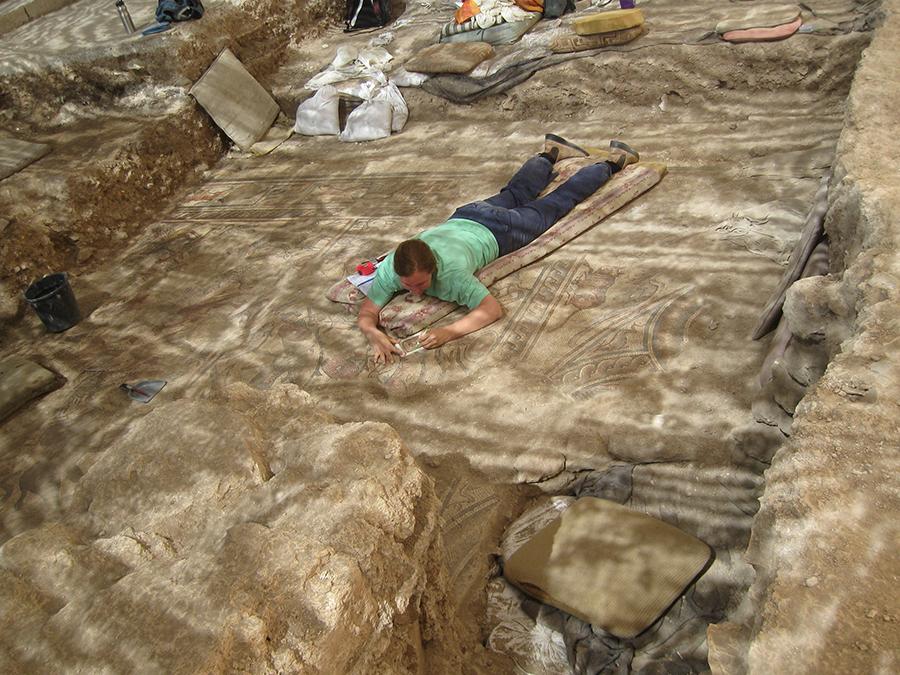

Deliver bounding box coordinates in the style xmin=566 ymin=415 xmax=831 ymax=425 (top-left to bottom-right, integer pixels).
xmin=450 ymin=155 xmax=619 ymax=255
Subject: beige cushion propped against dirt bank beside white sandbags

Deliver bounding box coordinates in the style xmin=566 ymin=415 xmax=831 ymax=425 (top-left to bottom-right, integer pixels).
xmin=190 ymin=49 xmax=279 ymax=150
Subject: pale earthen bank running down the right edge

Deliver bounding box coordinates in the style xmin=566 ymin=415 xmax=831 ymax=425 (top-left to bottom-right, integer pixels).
xmin=709 ymin=0 xmax=900 ymax=673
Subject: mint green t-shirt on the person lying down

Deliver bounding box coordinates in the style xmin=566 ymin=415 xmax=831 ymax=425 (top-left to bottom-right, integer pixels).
xmin=369 ymin=218 xmax=500 ymax=309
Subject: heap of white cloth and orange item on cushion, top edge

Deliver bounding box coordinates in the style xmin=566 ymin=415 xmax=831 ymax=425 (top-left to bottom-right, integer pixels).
xmin=440 ymin=0 xmax=543 ymax=45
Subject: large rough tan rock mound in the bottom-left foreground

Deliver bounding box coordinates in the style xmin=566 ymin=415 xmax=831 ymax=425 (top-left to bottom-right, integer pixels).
xmin=0 ymin=385 xmax=464 ymax=673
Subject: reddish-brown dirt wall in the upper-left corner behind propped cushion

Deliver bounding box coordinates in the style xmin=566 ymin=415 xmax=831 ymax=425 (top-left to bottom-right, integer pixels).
xmin=0 ymin=0 xmax=343 ymax=323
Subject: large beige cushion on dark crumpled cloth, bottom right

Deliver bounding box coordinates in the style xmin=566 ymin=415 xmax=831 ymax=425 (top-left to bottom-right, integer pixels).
xmin=503 ymin=497 xmax=712 ymax=638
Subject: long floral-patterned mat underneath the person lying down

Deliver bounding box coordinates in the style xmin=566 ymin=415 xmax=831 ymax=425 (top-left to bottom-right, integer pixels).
xmin=326 ymin=157 xmax=666 ymax=337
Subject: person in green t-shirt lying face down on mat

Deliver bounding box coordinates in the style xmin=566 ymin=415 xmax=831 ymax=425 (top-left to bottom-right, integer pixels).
xmin=358 ymin=134 xmax=639 ymax=363
